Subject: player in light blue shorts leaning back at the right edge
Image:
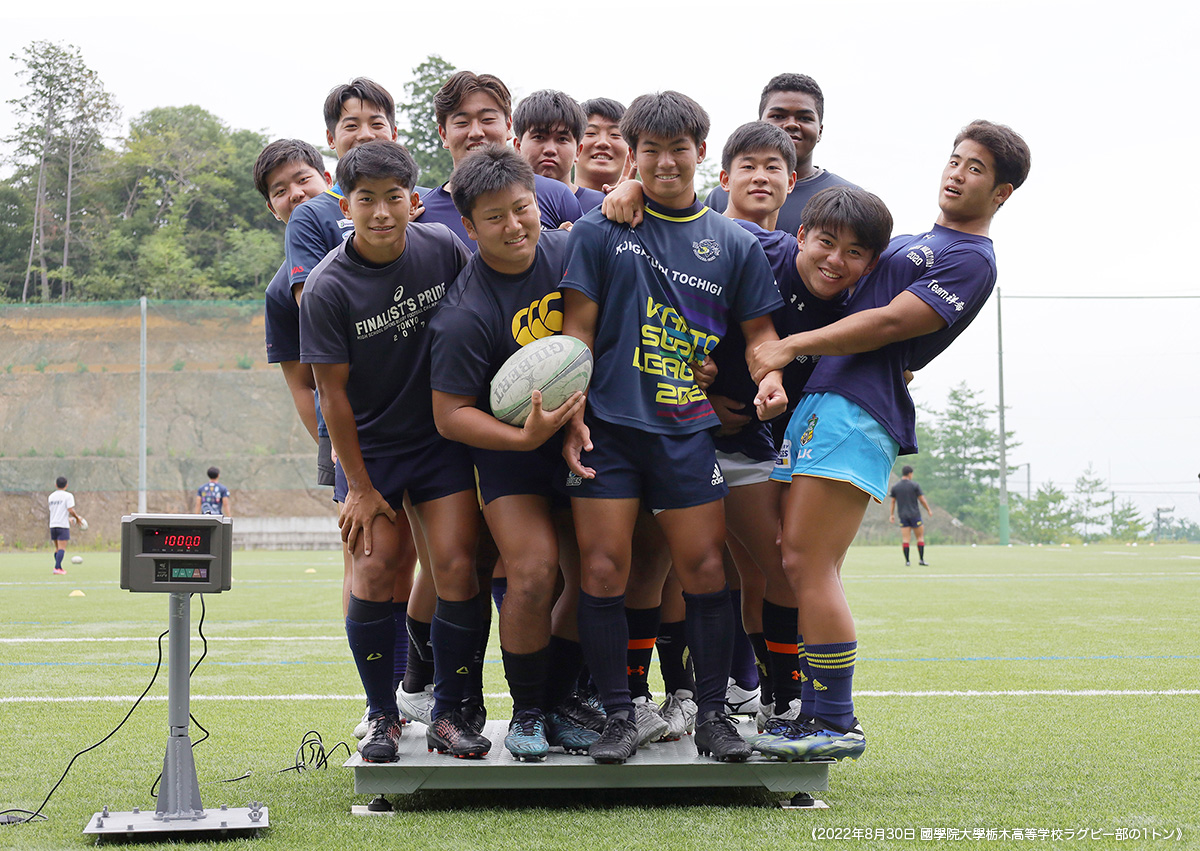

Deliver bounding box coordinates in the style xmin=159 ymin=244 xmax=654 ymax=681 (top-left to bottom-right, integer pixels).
xmin=750 ymin=121 xmax=1030 ymax=759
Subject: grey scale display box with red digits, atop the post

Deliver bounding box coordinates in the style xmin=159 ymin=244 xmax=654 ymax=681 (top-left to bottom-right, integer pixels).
xmin=121 ymin=514 xmax=233 ymax=594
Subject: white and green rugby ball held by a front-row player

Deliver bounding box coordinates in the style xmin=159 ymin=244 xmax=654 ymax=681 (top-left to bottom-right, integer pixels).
xmin=492 ymin=334 xmax=592 ymax=426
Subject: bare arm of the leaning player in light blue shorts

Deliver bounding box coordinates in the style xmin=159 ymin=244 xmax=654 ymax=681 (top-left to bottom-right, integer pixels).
xmin=746 ymin=290 xmax=946 ymax=380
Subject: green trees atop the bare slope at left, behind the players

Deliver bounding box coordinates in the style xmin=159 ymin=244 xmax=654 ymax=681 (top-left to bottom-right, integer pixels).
xmin=0 ymin=41 xmax=455 ymax=302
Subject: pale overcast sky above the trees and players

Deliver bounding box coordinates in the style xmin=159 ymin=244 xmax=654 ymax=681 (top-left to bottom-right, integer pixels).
xmin=0 ymin=0 xmax=1200 ymax=520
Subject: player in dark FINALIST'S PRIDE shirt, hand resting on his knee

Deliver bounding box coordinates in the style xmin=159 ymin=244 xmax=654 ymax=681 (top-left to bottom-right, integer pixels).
xmin=301 ymin=140 xmax=491 ymax=762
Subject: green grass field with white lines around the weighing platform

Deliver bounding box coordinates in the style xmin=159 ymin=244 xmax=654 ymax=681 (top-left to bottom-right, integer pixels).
xmin=0 ymin=545 xmax=1200 ymax=851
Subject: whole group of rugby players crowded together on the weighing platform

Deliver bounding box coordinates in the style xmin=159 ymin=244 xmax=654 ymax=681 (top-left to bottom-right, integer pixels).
xmin=254 ymin=71 xmax=1030 ymax=763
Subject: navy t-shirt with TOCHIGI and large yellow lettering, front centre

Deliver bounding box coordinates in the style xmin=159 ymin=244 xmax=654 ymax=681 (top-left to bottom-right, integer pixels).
xmin=562 ymin=199 xmax=782 ymax=435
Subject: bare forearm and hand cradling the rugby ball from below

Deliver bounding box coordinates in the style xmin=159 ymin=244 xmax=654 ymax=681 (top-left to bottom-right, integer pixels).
xmin=433 ymin=390 xmax=583 ymax=453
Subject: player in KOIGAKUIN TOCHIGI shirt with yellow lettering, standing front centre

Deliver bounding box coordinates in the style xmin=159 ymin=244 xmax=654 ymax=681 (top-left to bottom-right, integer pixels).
xmin=562 ymin=91 xmax=786 ymax=762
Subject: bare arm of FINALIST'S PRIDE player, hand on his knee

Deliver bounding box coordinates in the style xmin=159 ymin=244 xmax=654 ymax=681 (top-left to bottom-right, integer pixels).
xmin=312 ymin=364 xmax=396 ymax=556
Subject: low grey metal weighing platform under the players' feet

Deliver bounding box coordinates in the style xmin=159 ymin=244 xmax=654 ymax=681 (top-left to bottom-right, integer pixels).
xmin=346 ymin=720 xmax=833 ymax=815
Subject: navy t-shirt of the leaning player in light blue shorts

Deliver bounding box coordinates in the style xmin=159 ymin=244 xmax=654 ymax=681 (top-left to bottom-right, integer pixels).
xmin=805 ymin=224 xmax=996 ymax=455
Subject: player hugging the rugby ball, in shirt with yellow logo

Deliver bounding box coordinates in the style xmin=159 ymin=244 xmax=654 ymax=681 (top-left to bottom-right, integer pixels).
xmin=432 ymin=145 xmax=598 ymax=760
